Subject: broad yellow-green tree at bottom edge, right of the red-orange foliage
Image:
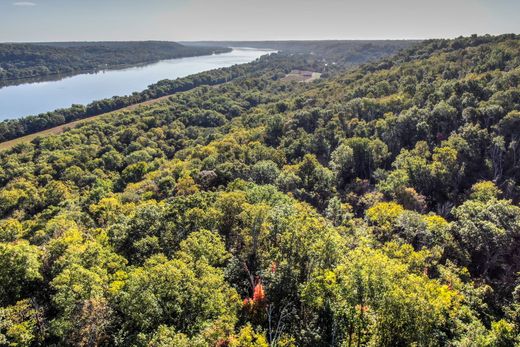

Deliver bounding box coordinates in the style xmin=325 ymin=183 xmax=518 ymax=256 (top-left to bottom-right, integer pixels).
xmin=303 ymin=247 xmax=460 ymax=346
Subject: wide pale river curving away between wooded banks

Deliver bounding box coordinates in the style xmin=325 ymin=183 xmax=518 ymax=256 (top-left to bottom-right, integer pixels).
xmin=0 ymin=48 xmax=272 ymax=121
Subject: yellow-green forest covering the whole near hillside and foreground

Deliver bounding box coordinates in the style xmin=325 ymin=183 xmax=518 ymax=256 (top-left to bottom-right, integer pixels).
xmin=0 ymin=35 xmax=520 ymax=347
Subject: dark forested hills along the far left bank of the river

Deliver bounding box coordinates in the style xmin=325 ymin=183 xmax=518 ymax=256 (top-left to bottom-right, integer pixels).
xmin=0 ymin=41 xmax=230 ymax=84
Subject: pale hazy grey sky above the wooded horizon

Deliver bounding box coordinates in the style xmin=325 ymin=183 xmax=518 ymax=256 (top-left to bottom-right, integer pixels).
xmin=0 ymin=0 xmax=520 ymax=42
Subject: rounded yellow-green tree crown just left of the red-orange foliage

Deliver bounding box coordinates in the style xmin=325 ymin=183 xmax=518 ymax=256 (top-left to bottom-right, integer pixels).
xmin=118 ymin=256 xmax=238 ymax=336
